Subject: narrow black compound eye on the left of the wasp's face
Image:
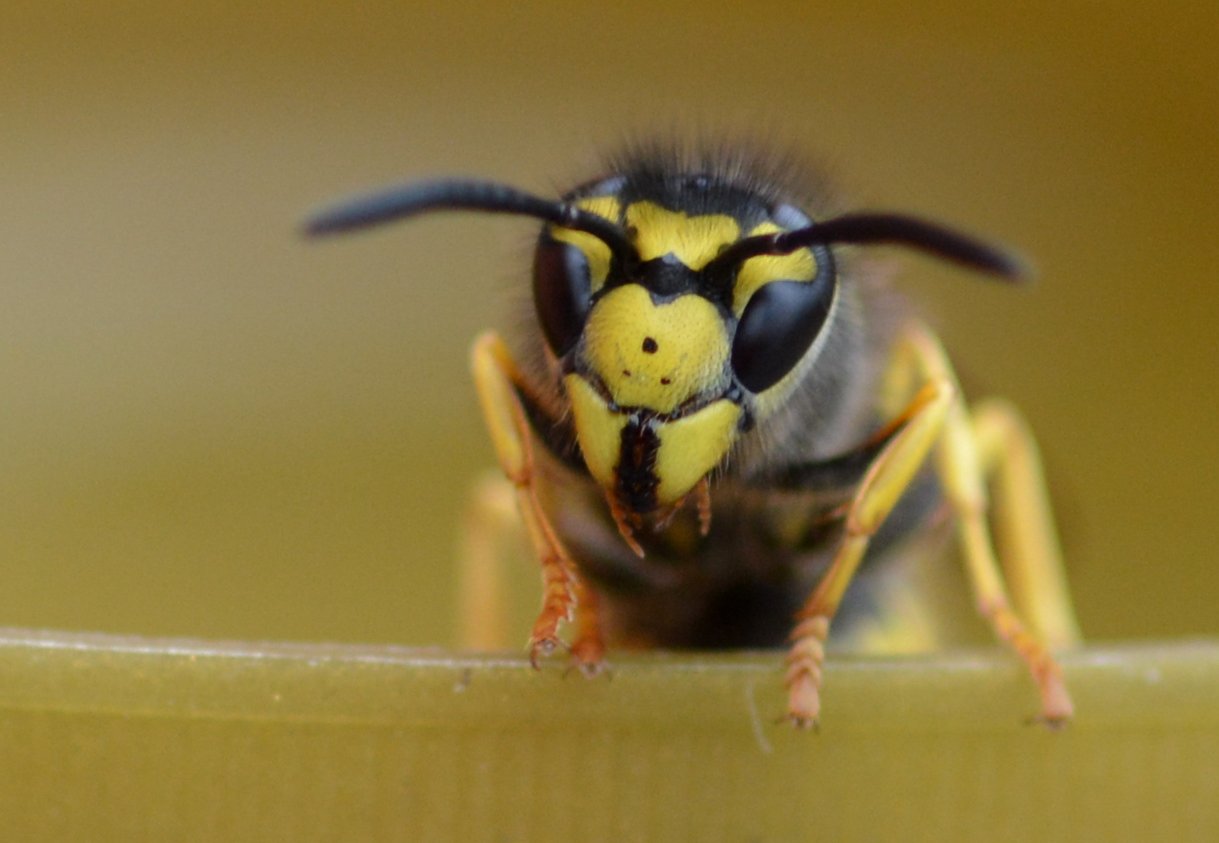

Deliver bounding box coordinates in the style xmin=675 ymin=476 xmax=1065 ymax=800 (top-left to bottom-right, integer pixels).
xmin=534 ymin=234 xmax=591 ymax=357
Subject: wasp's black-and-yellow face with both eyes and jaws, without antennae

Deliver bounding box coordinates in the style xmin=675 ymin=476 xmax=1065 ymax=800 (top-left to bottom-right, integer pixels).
xmin=534 ymin=175 xmax=834 ymax=514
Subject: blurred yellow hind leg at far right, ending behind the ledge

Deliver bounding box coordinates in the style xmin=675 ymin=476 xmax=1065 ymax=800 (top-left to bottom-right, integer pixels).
xmin=972 ymin=398 xmax=1082 ymax=649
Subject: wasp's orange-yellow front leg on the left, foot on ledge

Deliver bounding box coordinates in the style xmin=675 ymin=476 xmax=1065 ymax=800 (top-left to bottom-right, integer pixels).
xmin=471 ymin=333 xmax=603 ymax=668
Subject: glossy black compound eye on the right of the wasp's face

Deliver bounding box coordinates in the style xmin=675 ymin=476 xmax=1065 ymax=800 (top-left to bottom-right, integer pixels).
xmin=733 ymin=272 xmax=834 ymax=393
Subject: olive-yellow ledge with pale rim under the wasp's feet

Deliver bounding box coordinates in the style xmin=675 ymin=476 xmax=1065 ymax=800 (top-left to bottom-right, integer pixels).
xmin=0 ymin=630 xmax=1219 ymax=842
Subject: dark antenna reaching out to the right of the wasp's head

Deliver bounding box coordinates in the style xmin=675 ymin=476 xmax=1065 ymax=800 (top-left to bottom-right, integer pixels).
xmin=712 ymin=213 xmax=1032 ymax=281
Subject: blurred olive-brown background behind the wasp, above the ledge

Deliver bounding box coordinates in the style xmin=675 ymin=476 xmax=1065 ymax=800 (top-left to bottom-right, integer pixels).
xmin=0 ymin=0 xmax=1219 ymax=643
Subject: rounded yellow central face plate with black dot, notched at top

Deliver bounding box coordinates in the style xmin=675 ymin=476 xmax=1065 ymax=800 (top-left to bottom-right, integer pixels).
xmin=584 ymin=284 xmax=729 ymax=413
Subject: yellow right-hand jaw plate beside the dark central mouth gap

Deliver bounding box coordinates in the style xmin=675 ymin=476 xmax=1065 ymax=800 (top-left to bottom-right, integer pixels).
xmin=655 ymin=398 xmax=741 ymax=506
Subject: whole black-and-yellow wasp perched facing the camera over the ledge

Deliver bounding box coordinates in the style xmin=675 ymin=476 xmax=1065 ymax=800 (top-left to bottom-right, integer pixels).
xmin=307 ymin=141 xmax=1079 ymax=727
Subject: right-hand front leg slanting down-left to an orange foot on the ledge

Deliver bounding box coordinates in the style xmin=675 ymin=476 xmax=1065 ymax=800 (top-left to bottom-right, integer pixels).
xmin=786 ymin=378 xmax=957 ymax=727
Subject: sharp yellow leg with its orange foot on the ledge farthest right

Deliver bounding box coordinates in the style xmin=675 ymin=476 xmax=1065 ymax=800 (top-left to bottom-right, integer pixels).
xmin=895 ymin=325 xmax=1074 ymax=726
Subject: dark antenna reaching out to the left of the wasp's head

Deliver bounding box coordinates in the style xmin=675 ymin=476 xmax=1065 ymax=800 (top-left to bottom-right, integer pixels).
xmin=305 ymin=179 xmax=638 ymax=259
